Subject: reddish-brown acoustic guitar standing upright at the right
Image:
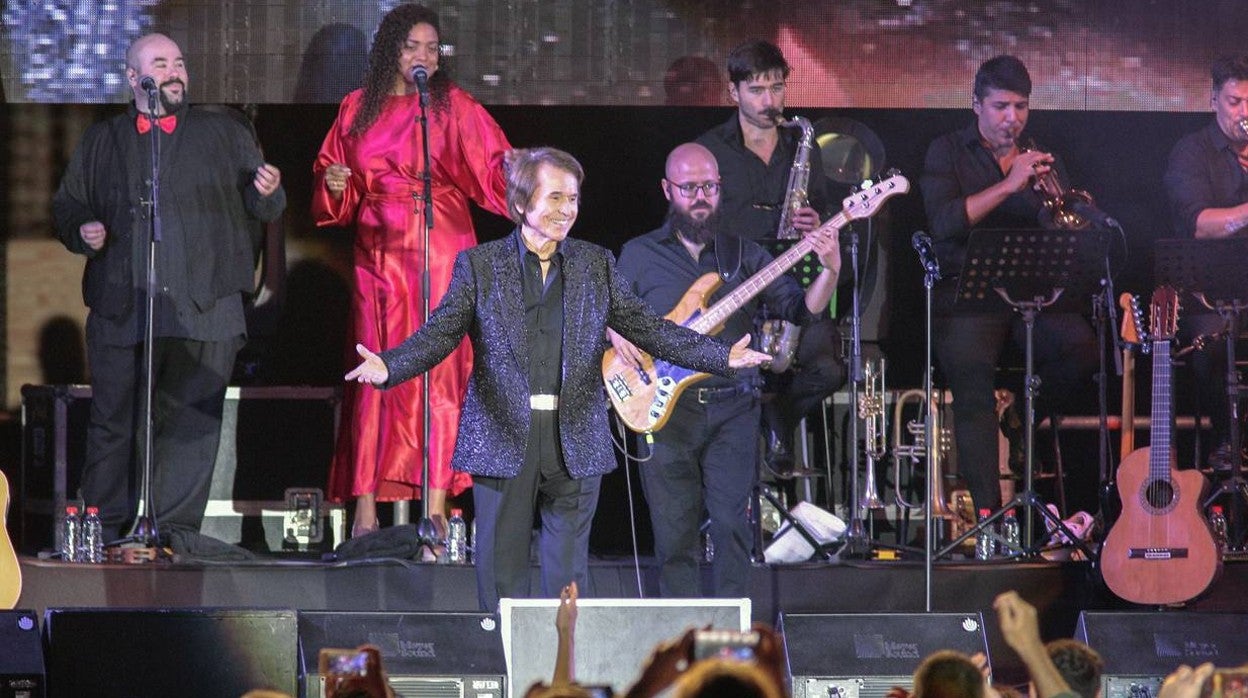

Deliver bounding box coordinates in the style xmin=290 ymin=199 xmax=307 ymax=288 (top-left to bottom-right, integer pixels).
xmin=1101 ymin=286 xmax=1222 ymax=604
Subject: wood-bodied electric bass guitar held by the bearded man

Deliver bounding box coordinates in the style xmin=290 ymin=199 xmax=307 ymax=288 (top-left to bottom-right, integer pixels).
xmin=603 ymin=175 xmax=910 ymax=433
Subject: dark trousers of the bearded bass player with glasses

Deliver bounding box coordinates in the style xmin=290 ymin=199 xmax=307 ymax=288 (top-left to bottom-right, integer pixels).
xmin=640 ymin=388 xmax=759 ymax=598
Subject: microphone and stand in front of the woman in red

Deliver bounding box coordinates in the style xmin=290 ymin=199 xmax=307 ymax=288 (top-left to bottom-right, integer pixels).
xmin=409 ymin=76 xmax=443 ymax=556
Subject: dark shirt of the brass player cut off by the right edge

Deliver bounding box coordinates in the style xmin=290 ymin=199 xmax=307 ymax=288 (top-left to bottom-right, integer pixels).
xmin=1163 ymin=121 xmax=1248 ymax=237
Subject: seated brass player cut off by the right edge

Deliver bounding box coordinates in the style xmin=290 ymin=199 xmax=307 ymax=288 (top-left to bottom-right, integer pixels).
xmin=1163 ymin=55 xmax=1248 ymax=469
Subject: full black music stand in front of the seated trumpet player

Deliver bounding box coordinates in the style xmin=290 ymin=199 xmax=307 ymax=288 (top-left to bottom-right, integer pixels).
xmin=935 ymin=230 xmax=1108 ymax=559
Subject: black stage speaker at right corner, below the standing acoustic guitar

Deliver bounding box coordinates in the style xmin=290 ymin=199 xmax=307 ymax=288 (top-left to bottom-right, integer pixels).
xmin=1075 ymin=611 xmax=1248 ymax=698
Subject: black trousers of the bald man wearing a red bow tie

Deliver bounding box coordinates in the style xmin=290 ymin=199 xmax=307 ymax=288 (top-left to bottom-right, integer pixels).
xmin=81 ymin=336 xmax=242 ymax=541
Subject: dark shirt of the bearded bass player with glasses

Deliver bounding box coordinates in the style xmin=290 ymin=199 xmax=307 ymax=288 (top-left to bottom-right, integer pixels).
xmin=617 ymin=224 xmax=815 ymax=387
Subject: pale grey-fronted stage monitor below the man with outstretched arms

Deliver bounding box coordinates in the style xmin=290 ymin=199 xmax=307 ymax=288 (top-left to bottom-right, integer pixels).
xmin=499 ymin=598 xmax=750 ymax=696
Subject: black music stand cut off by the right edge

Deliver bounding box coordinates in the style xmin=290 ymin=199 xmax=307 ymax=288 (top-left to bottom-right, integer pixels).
xmin=1154 ymin=237 xmax=1248 ymax=529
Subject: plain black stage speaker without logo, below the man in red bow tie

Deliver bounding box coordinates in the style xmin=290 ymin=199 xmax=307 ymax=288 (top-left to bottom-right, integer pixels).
xmin=44 ymin=608 xmax=298 ymax=698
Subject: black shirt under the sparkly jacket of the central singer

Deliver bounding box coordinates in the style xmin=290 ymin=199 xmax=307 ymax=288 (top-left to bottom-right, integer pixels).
xmin=515 ymin=235 xmax=563 ymax=395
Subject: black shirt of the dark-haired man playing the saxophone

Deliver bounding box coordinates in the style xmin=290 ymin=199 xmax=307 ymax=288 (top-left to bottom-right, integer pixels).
xmin=698 ymin=111 xmax=839 ymax=243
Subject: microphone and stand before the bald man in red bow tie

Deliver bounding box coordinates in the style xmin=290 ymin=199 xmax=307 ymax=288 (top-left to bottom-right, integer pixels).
xmin=119 ymin=89 xmax=161 ymax=548
